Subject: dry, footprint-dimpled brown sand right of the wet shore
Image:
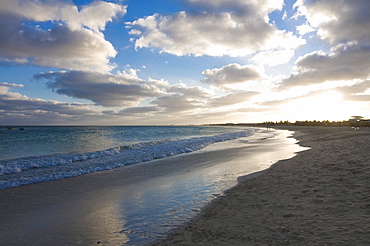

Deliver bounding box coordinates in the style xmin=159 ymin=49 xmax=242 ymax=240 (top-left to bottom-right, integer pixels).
xmin=157 ymin=127 xmax=370 ymax=246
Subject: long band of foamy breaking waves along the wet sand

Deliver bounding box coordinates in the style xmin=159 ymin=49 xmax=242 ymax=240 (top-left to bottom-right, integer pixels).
xmin=0 ymin=129 xmax=255 ymax=189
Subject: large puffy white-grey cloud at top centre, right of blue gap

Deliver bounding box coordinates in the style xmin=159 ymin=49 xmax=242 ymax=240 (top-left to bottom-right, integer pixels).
xmin=127 ymin=1 xmax=305 ymax=57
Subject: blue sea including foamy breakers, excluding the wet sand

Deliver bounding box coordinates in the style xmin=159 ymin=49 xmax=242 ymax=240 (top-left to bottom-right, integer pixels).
xmin=0 ymin=126 xmax=255 ymax=189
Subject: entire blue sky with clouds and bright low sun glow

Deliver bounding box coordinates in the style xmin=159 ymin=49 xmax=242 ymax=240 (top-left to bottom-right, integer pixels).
xmin=0 ymin=0 xmax=370 ymax=125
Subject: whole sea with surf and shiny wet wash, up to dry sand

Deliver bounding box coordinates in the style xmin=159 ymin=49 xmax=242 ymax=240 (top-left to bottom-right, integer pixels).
xmin=0 ymin=126 xmax=302 ymax=245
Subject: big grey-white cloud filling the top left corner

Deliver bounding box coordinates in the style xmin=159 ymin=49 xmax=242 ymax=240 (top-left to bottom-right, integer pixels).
xmin=0 ymin=0 xmax=126 ymax=72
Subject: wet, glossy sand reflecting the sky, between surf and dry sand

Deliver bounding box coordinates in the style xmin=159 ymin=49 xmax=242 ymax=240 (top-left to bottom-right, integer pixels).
xmin=0 ymin=128 xmax=300 ymax=245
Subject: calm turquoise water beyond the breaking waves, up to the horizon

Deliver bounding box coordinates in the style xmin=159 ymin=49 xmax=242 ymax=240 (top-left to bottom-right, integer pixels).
xmin=0 ymin=126 xmax=240 ymax=160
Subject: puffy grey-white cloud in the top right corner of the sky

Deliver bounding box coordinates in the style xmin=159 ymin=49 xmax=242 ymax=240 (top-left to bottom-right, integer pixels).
xmin=295 ymin=0 xmax=370 ymax=44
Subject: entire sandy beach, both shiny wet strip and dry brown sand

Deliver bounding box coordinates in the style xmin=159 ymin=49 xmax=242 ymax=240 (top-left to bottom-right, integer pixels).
xmin=0 ymin=127 xmax=370 ymax=245
